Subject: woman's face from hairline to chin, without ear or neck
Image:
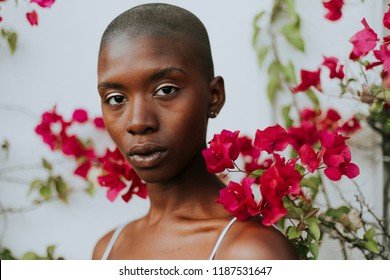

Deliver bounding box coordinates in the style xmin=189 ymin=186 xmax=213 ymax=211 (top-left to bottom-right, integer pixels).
xmin=98 ymin=36 xmax=210 ymax=183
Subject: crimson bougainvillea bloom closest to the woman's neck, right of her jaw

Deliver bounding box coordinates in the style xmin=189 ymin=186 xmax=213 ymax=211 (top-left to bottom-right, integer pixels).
xmin=202 ymin=129 xmax=240 ymax=173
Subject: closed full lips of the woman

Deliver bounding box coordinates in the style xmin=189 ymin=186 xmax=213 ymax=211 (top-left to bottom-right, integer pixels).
xmin=128 ymin=143 xmax=167 ymax=168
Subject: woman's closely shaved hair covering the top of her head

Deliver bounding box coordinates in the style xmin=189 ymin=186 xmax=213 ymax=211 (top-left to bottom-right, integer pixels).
xmin=100 ymin=3 xmax=214 ymax=79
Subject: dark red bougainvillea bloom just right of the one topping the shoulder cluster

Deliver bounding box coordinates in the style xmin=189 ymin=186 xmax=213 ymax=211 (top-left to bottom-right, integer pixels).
xmin=287 ymin=121 xmax=319 ymax=152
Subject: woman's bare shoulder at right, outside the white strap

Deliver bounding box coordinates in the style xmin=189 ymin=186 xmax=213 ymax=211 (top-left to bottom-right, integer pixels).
xmin=216 ymin=217 xmax=297 ymax=260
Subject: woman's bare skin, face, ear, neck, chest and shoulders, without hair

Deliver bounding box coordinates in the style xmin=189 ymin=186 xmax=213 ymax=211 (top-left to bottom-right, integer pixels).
xmin=93 ymin=35 xmax=296 ymax=260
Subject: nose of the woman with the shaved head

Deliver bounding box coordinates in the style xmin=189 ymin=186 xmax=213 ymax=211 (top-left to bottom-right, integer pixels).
xmin=126 ymin=98 xmax=158 ymax=135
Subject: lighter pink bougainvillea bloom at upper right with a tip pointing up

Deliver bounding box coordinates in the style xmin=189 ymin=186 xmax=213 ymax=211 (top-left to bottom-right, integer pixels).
xmin=349 ymin=18 xmax=379 ymax=60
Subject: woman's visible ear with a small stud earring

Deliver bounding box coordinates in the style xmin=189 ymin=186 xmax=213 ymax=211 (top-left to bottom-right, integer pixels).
xmin=209 ymin=76 xmax=225 ymax=118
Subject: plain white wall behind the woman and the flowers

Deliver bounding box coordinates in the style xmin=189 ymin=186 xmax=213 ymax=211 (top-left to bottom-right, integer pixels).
xmin=0 ymin=0 xmax=382 ymax=259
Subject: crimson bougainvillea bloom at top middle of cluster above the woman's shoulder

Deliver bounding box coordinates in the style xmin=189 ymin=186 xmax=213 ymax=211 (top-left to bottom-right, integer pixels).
xmin=254 ymin=124 xmax=288 ymax=154
